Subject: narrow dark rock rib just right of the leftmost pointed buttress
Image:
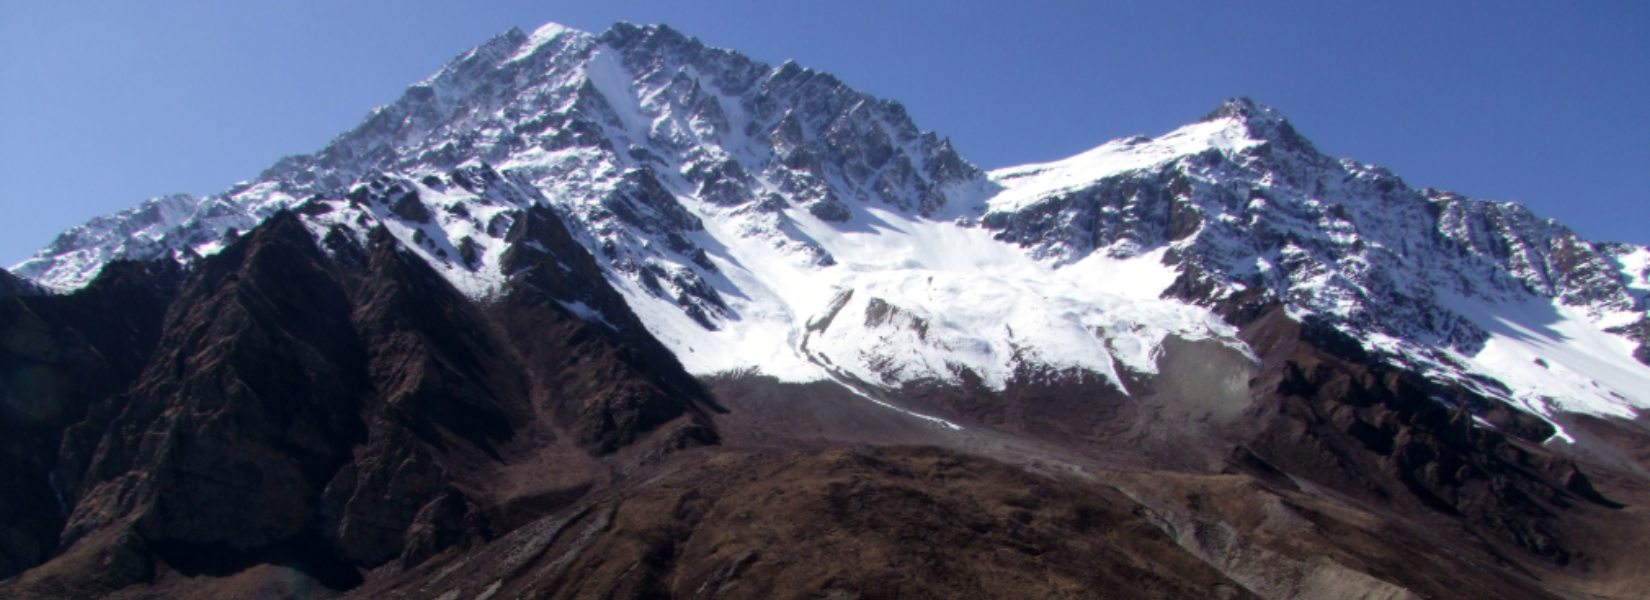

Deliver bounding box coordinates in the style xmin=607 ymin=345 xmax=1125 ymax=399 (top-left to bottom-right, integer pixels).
xmin=318 ymin=229 xmax=533 ymax=567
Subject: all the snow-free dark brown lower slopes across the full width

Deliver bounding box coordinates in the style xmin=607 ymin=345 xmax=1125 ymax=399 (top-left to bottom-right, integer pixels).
xmin=0 ymin=214 xmax=1650 ymax=600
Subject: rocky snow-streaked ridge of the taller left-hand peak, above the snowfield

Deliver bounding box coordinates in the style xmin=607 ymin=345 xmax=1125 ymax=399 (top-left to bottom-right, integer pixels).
xmin=18 ymin=25 xmax=980 ymax=326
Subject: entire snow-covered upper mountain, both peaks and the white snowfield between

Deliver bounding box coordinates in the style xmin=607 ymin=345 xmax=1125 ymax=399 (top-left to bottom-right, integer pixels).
xmin=13 ymin=23 xmax=1650 ymax=435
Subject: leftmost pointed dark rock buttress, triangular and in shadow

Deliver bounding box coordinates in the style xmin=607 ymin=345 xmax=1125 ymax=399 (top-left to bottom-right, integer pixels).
xmin=63 ymin=212 xmax=370 ymax=552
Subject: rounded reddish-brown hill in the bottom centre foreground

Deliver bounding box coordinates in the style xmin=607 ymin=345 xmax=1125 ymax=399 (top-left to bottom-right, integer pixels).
xmin=334 ymin=447 xmax=1252 ymax=598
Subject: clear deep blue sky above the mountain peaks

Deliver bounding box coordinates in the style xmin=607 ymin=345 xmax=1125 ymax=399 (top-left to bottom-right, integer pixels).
xmin=0 ymin=0 xmax=1650 ymax=265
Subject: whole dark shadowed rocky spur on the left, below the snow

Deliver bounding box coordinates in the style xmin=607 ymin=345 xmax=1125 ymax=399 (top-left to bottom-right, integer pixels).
xmin=0 ymin=213 xmax=716 ymax=587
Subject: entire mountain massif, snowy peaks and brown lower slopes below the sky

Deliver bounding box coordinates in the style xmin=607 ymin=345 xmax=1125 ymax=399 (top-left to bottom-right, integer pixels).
xmin=0 ymin=23 xmax=1650 ymax=598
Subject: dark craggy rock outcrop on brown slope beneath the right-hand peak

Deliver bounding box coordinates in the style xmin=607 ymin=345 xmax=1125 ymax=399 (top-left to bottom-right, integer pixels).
xmin=1244 ymin=306 xmax=1620 ymax=565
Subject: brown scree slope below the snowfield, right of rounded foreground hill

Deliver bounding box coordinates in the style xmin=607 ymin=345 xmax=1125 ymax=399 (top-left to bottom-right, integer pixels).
xmin=693 ymin=308 xmax=1650 ymax=598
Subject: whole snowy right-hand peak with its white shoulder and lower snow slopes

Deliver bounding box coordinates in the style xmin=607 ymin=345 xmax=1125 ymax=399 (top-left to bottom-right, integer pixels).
xmin=982 ymin=99 xmax=1650 ymax=435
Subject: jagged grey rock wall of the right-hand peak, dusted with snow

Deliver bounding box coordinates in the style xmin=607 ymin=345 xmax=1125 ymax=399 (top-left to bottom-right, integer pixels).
xmin=982 ymin=99 xmax=1635 ymax=360
